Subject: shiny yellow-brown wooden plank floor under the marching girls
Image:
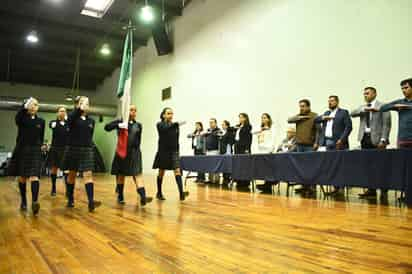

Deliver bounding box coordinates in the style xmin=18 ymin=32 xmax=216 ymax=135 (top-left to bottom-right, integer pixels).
xmin=0 ymin=175 xmax=412 ymax=273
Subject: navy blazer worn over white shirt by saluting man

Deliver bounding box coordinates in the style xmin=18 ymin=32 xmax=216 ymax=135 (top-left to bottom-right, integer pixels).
xmin=315 ymin=108 xmax=352 ymax=148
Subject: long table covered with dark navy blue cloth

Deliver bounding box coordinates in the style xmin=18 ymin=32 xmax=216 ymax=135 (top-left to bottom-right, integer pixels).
xmin=181 ymin=149 xmax=412 ymax=205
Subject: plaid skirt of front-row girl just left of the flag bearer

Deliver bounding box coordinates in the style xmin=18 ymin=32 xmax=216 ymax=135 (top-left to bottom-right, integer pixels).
xmin=62 ymin=146 xmax=95 ymax=171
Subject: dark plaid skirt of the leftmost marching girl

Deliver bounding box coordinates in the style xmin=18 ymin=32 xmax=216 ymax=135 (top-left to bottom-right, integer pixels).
xmin=7 ymin=146 xmax=42 ymax=177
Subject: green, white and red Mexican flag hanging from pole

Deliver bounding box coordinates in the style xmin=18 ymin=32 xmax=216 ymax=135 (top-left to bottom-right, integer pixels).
xmin=116 ymin=27 xmax=133 ymax=159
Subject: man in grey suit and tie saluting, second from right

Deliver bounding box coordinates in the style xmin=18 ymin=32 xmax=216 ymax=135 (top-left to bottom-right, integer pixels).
xmin=351 ymin=87 xmax=391 ymax=198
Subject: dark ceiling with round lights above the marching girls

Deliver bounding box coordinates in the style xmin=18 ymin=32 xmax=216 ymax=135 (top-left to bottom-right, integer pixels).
xmin=0 ymin=0 xmax=189 ymax=90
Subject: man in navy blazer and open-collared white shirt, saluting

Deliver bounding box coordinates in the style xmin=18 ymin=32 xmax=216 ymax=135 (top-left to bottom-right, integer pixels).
xmin=315 ymin=95 xmax=352 ymax=195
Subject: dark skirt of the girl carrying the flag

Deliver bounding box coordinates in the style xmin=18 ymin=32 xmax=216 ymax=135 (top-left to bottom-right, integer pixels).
xmin=111 ymin=148 xmax=142 ymax=176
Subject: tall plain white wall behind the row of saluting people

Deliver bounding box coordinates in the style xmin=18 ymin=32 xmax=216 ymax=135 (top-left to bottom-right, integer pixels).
xmin=99 ymin=0 xmax=412 ymax=172
